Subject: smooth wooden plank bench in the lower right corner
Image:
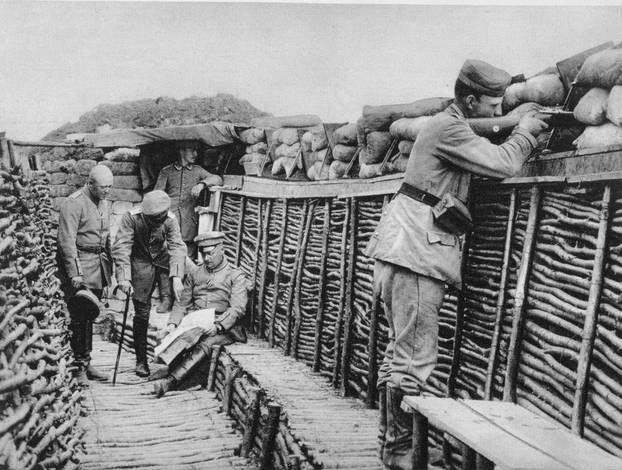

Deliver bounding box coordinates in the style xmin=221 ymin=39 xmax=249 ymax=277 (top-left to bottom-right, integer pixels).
xmin=402 ymin=396 xmax=622 ymax=470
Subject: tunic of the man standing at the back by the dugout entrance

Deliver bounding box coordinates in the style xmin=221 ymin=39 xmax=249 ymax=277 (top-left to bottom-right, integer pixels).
xmin=153 ymin=163 xmax=222 ymax=243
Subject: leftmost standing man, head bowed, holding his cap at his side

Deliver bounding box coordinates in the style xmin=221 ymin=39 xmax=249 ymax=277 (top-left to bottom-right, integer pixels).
xmin=56 ymin=165 xmax=113 ymax=384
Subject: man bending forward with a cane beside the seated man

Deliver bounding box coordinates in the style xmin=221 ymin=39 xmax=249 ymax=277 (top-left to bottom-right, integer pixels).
xmin=112 ymin=191 xmax=186 ymax=377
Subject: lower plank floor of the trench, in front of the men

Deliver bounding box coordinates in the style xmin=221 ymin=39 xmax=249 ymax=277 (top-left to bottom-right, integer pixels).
xmin=79 ymin=338 xmax=256 ymax=470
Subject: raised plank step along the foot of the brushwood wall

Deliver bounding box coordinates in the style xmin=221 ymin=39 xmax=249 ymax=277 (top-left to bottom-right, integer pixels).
xmin=226 ymin=338 xmax=382 ymax=470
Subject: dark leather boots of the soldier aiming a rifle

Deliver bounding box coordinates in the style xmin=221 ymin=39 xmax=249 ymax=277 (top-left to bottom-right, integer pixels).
xmin=382 ymin=385 xmax=413 ymax=470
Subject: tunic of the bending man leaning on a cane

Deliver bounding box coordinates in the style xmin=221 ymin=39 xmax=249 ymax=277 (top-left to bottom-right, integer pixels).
xmin=112 ymin=207 xmax=186 ymax=302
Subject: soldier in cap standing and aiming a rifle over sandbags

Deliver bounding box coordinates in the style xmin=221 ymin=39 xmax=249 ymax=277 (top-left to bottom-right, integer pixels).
xmin=365 ymin=60 xmax=547 ymax=469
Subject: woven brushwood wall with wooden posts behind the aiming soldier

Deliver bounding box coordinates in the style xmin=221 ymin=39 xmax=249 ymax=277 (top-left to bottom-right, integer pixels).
xmin=219 ymin=175 xmax=622 ymax=456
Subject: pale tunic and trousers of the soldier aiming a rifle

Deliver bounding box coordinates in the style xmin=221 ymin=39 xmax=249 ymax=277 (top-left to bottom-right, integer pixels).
xmin=365 ymin=104 xmax=536 ymax=394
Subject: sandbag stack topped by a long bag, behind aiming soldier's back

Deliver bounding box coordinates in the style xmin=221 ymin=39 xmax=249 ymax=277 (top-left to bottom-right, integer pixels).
xmin=357 ymin=98 xmax=452 ymax=178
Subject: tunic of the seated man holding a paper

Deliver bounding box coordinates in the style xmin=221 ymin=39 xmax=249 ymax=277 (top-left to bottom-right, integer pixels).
xmin=169 ymin=260 xmax=248 ymax=338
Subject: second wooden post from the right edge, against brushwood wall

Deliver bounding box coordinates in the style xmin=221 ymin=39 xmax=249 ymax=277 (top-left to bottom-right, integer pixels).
xmin=503 ymin=186 xmax=541 ymax=402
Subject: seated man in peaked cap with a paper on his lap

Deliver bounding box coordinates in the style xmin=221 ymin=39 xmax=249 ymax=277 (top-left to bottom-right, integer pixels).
xmin=154 ymin=232 xmax=247 ymax=398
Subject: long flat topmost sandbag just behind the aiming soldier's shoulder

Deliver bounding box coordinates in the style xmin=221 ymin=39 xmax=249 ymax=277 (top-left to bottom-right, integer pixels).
xmin=358 ymin=98 xmax=453 ymax=132
